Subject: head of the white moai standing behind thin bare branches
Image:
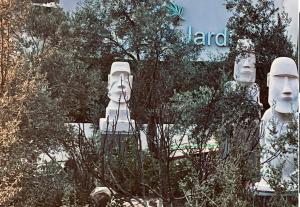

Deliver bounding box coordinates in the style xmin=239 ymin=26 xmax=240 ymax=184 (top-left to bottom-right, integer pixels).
xmin=108 ymin=62 xmax=133 ymax=103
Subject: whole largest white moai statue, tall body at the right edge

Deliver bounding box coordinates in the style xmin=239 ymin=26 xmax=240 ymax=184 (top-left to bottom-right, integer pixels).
xmin=255 ymin=57 xmax=299 ymax=193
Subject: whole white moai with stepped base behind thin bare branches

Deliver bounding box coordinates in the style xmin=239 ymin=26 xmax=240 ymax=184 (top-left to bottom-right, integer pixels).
xmin=100 ymin=62 xmax=134 ymax=134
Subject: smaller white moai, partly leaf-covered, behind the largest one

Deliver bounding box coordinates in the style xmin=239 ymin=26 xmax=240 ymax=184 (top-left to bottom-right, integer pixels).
xmin=225 ymin=39 xmax=262 ymax=106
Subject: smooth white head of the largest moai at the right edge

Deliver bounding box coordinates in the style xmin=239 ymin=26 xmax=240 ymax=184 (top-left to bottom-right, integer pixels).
xmin=267 ymin=57 xmax=299 ymax=113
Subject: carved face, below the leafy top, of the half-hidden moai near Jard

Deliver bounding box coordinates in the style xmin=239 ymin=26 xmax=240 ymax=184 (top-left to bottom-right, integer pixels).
xmin=234 ymin=53 xmax=256 ymax=83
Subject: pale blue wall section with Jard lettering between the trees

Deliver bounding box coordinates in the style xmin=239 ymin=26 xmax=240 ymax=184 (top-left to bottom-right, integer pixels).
xmin=168 ymin=0 xmax=232 ymax=61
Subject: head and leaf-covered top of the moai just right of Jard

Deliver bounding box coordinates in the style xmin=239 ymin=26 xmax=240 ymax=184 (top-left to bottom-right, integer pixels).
xmin=234 ymin=39 xmax=256 ymax=83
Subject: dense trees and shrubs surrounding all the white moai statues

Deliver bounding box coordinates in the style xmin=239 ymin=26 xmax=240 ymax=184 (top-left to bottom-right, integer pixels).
xmin=0 ymin=0 xmax=297 ymax=207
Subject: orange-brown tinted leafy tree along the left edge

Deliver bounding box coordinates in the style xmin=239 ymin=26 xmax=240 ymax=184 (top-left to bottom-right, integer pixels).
xmin=0 ymin=1 xmax=74 ymax=206
